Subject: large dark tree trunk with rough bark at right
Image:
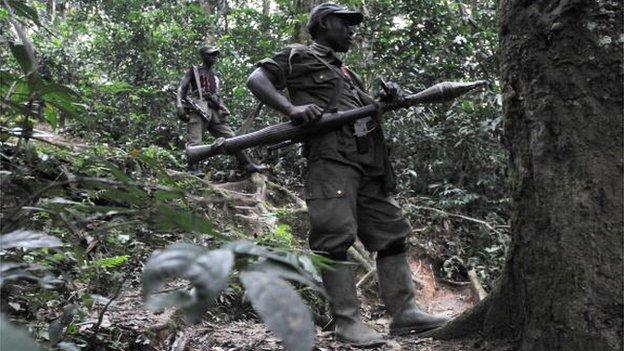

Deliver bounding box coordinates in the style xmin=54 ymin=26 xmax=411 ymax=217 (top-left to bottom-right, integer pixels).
xmin=431 ymin=0 xmax=624 ymax=351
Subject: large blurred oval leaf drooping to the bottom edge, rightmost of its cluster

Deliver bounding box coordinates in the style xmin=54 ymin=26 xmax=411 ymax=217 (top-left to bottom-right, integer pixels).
xmin=240 ymin=272 xmax=315 ymax=351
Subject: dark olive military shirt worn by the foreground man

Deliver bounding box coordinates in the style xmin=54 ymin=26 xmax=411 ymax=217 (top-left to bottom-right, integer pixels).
xmin=258 ymin=43 xmax=392 ymax=177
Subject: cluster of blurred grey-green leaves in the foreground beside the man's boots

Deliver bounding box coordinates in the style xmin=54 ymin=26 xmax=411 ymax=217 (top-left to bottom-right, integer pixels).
xmin=143 ymin=241 xmax=318 ymax=350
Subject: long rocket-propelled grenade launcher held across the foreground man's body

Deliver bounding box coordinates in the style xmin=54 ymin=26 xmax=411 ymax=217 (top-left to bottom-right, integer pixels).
xmin=186 ymin=80 xmax=486 ymax=164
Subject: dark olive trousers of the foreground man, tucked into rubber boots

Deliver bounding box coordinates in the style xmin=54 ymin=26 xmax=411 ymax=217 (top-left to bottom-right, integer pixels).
xmin=305 ymin=159 xmax=411 ymax=254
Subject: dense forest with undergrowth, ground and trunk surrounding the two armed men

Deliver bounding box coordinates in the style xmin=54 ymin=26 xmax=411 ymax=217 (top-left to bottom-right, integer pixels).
xmin=0 ymin=0 xmax=624 ymax=351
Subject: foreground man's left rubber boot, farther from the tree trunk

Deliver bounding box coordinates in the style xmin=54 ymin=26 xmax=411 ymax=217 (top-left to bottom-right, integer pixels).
xmin=321 ymin=263 xmax=386 ymax=347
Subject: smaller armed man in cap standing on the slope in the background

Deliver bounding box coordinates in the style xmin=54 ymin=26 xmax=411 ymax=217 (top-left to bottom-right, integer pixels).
xmin=176 ymin=46 xmax=266 ymax=174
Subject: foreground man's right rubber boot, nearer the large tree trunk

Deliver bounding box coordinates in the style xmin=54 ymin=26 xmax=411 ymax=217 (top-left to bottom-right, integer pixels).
xmin=377 ymin=253 xmax=449 ymax=335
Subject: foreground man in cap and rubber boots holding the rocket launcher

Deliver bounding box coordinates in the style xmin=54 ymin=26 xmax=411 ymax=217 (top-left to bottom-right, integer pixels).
xmin=247 ymin=3 xmax=447 ymax=346
